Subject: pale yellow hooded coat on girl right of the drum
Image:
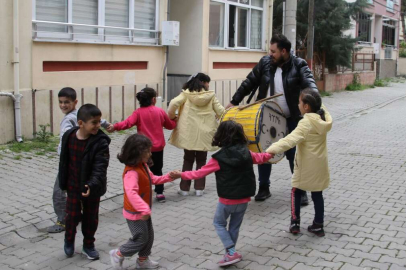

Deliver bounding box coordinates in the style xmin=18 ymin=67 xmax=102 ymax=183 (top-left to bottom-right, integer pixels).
xmin=266 ymin=106 xmax=333 ymax=191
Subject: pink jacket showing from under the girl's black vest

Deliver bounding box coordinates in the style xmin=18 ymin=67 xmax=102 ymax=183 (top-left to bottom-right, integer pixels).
xmin=181 ymin=151 xmax=271 ymax=205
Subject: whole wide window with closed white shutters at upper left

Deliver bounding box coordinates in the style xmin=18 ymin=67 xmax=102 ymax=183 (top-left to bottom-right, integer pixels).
xmin=32 ymin=0 xmax=159 ymax=45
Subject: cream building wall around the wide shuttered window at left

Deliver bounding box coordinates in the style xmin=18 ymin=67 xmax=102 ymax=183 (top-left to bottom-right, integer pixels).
xmin=0 ymin=0 xmax=167 ymax=144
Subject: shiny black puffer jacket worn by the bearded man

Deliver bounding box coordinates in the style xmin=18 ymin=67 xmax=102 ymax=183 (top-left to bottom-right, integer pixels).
xmin=231 ymin=55 xmax=318 ymax=119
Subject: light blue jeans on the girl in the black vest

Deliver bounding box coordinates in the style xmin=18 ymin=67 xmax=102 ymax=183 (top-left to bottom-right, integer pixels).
xmin=213 ymin=202 xmax=248 ymax=249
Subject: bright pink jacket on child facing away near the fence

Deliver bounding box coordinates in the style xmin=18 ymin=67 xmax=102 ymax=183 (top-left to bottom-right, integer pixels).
xmin=114 ymin=105 xmax=176 ymax=152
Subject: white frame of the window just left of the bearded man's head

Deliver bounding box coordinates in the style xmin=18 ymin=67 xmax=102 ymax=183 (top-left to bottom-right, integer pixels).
xmin=209 ymin=0 xmax=268 ymax=51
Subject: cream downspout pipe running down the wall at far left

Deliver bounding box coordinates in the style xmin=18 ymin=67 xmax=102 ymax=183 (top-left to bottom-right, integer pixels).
xmin=13 ymin=0 xmax=23 ymax=142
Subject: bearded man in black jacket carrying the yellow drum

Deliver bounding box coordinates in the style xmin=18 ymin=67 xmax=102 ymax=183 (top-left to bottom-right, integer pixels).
xmin=227 ymin=35 xmax=318 ymax=205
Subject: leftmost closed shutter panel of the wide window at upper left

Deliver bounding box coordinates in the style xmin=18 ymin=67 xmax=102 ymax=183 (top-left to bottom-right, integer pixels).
xmin=35 ymin=0 xmax=68 ymax=33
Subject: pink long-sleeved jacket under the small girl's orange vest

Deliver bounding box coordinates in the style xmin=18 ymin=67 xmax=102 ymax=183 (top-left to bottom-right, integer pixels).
xmin=123 ymin=171 xmax=172 ymax=220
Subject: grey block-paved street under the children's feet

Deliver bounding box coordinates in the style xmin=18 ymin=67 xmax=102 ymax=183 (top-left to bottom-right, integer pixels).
xmin=0 ymin=83 xmax=406 ymax=270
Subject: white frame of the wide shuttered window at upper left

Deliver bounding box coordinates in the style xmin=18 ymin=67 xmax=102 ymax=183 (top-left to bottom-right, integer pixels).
xmin=32 ymin=0 xmax=161 ymax=46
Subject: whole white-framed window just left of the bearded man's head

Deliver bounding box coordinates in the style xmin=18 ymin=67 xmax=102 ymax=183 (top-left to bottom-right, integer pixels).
xmin=209 ymin=0 xmax=264 ymax=50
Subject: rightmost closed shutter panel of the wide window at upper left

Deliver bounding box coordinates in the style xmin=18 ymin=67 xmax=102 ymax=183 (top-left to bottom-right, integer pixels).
xmin=134 ymin=0 xmax=156 ymax=38
